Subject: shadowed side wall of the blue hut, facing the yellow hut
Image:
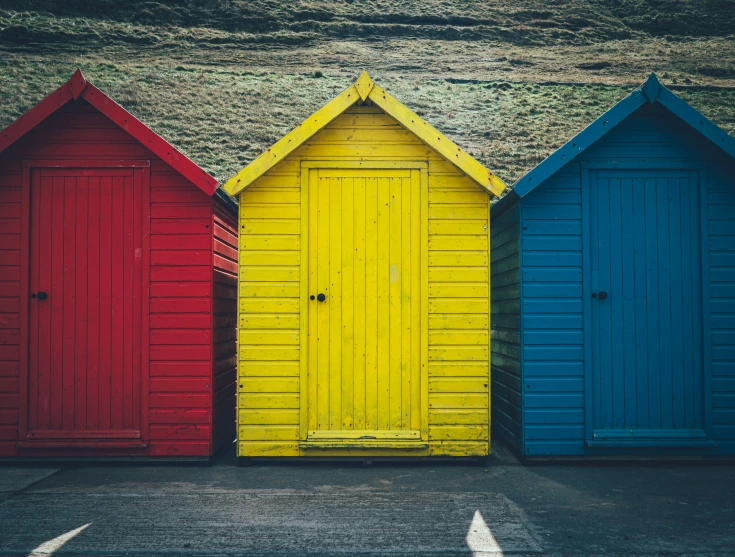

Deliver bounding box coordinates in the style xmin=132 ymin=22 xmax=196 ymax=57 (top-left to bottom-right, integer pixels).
xmin=490 ymin=202 xmax=523 ymax=451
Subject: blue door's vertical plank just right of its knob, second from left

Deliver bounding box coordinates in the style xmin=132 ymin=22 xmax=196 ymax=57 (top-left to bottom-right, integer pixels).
xmin=602 ymin=178 xmax=625 ymax=429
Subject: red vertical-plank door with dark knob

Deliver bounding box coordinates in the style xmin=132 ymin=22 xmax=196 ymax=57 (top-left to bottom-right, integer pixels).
xmin=25 ymin=167 xmax=148 ymax=447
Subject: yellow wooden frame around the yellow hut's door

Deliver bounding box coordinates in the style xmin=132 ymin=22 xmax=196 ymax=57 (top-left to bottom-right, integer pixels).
xmin=299 ymin=160 xmax=429 ymax=448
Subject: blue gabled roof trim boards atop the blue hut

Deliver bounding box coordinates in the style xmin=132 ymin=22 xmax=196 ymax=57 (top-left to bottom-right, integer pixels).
xmin=511 ymin=73 xmax=735 ymax=198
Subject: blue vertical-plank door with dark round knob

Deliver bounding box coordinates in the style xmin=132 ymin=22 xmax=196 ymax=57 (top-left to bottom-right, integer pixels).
xmin=585 ymin=170 xmax=709 ymax=448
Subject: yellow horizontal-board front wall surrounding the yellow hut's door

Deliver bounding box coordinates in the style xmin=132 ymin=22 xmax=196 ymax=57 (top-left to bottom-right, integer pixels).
xmin=238 ymin=106 xmax=490 ymax=457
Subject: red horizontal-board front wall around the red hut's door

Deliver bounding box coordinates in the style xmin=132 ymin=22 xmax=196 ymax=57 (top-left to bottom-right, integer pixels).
xmin=0 ymin=100 xmax=229 ymax=456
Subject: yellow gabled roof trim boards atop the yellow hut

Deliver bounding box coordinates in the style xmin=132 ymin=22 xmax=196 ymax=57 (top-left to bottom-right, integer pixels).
xmin=223 ymin=71 xmax=505 ymax=196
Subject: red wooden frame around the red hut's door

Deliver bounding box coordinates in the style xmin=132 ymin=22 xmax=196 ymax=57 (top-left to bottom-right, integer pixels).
xmin=18 ymin=159 xmax=151 ymax=449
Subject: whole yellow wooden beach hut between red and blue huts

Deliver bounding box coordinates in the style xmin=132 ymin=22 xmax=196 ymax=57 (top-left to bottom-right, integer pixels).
xmin=224 ymin=72 xmax=505 ymax=463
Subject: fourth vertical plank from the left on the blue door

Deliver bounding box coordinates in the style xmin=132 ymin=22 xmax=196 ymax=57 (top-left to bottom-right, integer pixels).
xmin=644 ymin=178 xmax=661 ymax=429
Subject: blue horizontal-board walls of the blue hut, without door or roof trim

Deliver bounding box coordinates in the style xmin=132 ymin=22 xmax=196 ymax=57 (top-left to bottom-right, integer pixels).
xmin=492 ymin=104 xmax=735 ymax=457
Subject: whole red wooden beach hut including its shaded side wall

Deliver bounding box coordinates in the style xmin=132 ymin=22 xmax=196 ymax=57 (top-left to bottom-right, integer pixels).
xmin=0 ymin=71 xmax=237 ymax=459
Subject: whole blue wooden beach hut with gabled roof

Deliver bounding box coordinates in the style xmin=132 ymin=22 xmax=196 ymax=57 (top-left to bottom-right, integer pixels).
xmin=491 ymin=74 xmax=735 ymax=458
